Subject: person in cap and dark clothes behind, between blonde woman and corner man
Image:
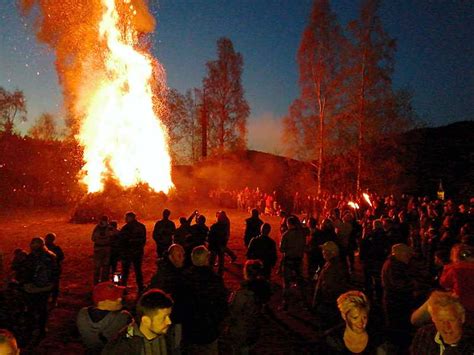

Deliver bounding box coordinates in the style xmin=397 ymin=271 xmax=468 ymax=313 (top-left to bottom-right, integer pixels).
xmin=382 ymin=243 xmax=415 ymax=351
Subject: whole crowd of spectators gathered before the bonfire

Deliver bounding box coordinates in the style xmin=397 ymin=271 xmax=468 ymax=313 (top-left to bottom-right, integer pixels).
xmin=0 ymin=190 xmax=474 ymax=355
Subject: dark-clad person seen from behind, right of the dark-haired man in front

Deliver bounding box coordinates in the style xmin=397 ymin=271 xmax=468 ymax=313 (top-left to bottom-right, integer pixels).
xmin=183 ymin=246 xmax=228 ymax=355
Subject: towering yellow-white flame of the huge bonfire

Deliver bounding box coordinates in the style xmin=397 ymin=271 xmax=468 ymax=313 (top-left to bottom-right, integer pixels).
xmin=77 ymin=0 xmax=173 ymax=193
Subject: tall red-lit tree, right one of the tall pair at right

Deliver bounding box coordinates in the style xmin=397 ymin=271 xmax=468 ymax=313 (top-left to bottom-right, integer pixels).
xmin=347 ymin=0 xmax=396 ymax=191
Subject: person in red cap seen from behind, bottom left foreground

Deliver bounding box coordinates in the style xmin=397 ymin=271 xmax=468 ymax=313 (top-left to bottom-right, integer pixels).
xmin=76 ymin=281 xmax=132 ymax=354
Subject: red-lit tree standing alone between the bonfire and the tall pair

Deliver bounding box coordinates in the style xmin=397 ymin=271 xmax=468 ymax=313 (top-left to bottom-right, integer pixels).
xmin=203 ymin=38 xmax=250 ymax=152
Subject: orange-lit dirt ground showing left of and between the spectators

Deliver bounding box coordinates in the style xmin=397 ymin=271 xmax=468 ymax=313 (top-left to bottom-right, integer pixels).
xmin=0 ymin=207 xmax=340 ymax=355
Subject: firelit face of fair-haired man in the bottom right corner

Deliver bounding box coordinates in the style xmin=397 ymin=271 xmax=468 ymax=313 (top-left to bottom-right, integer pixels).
xmin=431 ymin=305 xmax=465 ymax=344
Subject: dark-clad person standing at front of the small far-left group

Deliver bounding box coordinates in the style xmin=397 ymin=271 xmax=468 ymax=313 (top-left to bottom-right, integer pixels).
xmin=24 ymin=237 xmax=58 ymax=343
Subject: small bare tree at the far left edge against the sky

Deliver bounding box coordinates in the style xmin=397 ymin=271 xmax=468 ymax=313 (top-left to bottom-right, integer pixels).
xmin=0 ymin=87 xmax=27 ymax=134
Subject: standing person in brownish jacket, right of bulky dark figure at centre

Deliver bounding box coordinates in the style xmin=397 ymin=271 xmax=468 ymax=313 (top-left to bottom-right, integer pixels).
xmin=280 ymin=216 xmax=306 ymax=311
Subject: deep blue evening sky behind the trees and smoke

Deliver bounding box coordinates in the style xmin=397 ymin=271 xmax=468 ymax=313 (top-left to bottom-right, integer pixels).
xmin=0 ymin=0 xmax=474 ymax=153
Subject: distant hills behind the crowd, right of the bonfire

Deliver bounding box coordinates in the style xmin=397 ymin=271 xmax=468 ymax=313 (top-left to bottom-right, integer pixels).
xmin=174 ymin=121 xmax=474 ymax=198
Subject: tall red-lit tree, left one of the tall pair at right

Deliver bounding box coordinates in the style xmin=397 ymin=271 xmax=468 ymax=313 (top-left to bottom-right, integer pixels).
xmin=284 ymin=0 xmax=347 ymax=193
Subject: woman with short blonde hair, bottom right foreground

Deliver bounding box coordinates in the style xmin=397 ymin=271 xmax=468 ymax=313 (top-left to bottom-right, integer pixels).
xmin=326 ymin=291 xmax=395 ymax=355
